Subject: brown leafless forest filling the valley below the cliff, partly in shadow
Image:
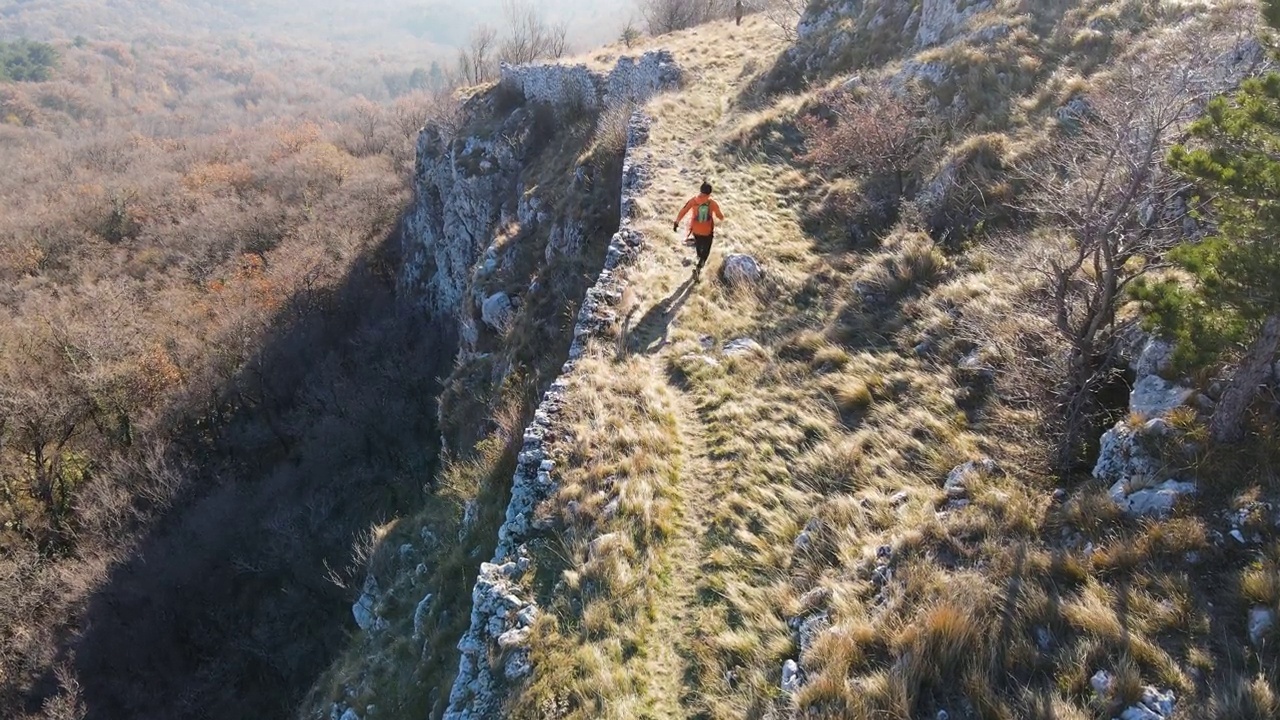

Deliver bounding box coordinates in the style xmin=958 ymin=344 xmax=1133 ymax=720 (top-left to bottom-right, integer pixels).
xmin=0 ymin=3 xmax=471 ymax=717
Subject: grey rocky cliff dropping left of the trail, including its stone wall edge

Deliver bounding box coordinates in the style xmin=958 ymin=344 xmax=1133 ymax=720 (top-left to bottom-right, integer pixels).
xmin=315 ymin=51 xmax=682 ymax=720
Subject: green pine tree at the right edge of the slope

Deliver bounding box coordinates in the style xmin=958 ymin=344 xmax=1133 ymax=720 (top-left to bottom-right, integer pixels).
xmin=1137 ymin=8 xmax=1280 ymax=442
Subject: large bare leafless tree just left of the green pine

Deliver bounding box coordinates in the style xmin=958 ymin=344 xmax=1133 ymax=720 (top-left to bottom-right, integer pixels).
xmin=1021 ymin=36 xmax=1217 ymax=468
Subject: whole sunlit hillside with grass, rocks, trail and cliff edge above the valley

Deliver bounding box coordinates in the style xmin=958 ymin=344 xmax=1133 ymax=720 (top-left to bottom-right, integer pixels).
xmin=302 ymin=0 xmax=1280 ymax=720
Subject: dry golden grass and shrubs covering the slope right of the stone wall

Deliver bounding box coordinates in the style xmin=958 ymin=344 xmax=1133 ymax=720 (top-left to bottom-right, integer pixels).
xmin=478 ymin=3 xmax=1280 ymax=720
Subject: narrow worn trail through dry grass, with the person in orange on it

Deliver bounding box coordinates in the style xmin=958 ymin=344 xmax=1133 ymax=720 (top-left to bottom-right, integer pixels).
xmin=614 ymin=23 xmax=772 ymax=719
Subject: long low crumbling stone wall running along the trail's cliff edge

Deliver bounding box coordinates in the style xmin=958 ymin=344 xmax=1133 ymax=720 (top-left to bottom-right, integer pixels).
xmin=444 ymin=113 xmax=649 ymax=720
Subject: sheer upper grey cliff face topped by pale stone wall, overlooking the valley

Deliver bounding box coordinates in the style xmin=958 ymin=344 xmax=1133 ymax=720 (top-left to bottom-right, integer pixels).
xmin=401 ymin=51 xmax=682 ymax=354
